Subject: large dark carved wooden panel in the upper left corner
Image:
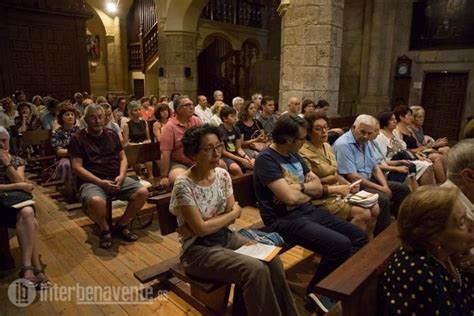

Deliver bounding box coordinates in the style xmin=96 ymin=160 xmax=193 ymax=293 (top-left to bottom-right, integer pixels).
xmin=0 ymin=5 xmax=90 ymax=99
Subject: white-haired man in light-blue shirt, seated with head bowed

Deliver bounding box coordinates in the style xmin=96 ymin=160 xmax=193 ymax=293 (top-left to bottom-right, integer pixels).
xmin=333 ymin=114 xmax=410 ymax=235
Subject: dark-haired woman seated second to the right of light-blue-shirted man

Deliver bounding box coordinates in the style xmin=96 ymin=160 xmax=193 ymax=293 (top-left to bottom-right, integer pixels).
xmin=393 ymin=105 xmax=446 ymax=183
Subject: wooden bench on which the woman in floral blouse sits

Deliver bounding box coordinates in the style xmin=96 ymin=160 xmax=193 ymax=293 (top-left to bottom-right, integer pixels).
xmin=134 ymin=173 xmax=256 ymax=315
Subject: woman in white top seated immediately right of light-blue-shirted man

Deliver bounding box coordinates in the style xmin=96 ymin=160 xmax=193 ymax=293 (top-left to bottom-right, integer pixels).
xmin=375 ymin=111 xmax=434 ymax=188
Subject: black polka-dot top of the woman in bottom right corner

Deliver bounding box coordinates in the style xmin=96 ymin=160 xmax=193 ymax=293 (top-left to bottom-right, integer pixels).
xmin=378 ymin=247 xmax=474 ymax=315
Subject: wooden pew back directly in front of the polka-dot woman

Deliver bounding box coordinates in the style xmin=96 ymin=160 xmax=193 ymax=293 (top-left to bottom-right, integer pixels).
xmin=316 ymin=222 xmax=400 ymax=316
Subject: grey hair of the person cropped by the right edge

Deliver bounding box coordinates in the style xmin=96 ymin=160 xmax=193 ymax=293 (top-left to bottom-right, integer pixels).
xmin=448 ymin=138 xmax=474 ymax=182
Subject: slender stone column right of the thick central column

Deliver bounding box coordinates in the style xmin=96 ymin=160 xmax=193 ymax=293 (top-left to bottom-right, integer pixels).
xmin=357 ymin=0 xmax=397 ymax=114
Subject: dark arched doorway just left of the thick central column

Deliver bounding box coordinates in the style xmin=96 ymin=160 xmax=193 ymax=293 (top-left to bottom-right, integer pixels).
xmin=198 ymin=36 xmax=239 ymax=104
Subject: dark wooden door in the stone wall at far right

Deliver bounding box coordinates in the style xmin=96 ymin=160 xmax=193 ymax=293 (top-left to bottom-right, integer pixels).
xmin=421 ymin=72 xmax=468 ymax=140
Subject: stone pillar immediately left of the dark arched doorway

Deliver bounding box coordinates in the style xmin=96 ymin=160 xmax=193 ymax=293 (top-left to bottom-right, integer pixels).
xmin=158 ymin=31 xmax=197 ymax=101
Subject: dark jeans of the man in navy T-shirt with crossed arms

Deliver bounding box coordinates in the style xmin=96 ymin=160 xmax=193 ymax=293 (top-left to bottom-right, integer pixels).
xmin=270 ymin=203 xmax=368 ymax=294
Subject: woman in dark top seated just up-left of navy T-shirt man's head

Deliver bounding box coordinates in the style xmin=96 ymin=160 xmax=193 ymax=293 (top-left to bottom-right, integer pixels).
xmin=236 ymin=101 xmax=269 ymax=158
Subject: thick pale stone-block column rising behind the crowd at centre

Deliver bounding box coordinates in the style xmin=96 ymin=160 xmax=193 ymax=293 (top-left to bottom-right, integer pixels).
xmin=279 ymin=0 xmax=344 ymax=116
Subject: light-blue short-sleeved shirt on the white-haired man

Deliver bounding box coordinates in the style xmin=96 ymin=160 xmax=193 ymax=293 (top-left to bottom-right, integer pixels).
xmin=332 ymin=131 xmax=377 ymax=180
